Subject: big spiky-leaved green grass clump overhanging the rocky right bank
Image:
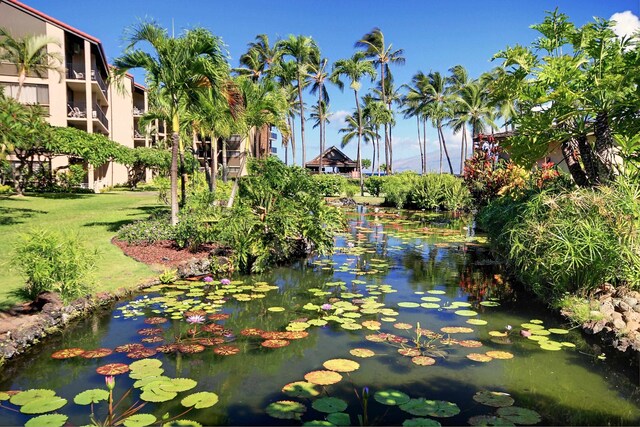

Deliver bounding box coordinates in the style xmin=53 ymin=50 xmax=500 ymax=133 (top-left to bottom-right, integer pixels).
xmin=479 ymin=178 xmax=640 ymax=302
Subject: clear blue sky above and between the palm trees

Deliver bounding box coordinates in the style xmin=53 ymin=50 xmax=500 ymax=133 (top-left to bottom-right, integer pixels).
xmin=23 ymin=0 xmax=640 ymax=169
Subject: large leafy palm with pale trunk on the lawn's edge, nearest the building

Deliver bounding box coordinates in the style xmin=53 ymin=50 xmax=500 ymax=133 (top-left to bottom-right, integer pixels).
xmin=114 ymin=22 xmax=229 ymax=225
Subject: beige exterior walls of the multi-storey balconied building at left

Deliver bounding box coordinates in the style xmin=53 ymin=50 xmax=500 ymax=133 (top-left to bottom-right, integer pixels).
xmin=0 ymin=0 xmax=149 ymax=191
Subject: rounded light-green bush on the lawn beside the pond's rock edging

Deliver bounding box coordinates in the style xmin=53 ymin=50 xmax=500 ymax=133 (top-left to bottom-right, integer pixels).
xmin=14 ymin=229 xmax=97 ymax=301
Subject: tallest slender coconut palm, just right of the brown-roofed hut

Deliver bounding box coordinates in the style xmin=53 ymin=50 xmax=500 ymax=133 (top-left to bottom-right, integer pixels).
xmin=355 ymin=27 xmax=405 ymax=173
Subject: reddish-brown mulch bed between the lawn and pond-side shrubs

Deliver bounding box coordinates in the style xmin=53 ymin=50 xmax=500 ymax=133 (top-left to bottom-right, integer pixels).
xmin=111 ymin=238 xmax=216 ymax=268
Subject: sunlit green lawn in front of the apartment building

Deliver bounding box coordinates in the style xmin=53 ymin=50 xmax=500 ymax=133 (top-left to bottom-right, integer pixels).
xmin=0 ymin=192 xmax=165 ymax=308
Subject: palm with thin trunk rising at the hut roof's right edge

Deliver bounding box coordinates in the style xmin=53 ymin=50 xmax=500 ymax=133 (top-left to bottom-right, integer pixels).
xmin=331 ymin=52 xmax=376 ymax=196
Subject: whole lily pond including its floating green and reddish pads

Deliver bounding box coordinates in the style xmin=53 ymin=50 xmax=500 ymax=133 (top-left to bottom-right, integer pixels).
xmin=0 ymin=207 xmax=640 ymax=426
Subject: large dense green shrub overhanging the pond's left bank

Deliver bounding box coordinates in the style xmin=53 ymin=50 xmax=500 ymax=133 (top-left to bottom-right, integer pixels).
xmin=217 ymin=157 xmax=344 ymax=272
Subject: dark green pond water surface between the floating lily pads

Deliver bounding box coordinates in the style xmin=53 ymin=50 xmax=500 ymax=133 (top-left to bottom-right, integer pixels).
xmin=0 ymin=206 xmax=640 ymax=425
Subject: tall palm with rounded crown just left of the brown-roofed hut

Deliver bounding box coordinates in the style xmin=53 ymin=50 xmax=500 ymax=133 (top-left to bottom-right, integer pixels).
xmin=276 ymin=35 xmax=320 ymax=166
